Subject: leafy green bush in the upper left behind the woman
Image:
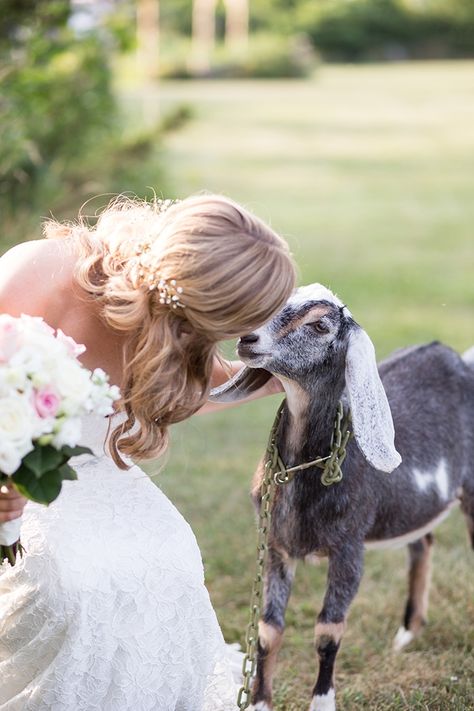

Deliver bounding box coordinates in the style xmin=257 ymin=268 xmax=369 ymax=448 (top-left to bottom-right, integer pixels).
xmin=0 ymin=0 xmax=176 ymax=249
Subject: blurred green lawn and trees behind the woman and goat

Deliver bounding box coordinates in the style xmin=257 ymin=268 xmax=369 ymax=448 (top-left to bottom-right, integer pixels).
xmin=0 ymin=0 xmax=474 ymax=711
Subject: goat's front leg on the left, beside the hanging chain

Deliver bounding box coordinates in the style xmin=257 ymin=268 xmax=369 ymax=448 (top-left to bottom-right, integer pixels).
xmin=252 ymin=546 xmax=296 ymax=711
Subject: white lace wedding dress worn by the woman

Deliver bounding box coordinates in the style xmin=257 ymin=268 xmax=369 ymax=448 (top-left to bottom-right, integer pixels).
xmin=0 ymin=416 xmax=241 ymax=711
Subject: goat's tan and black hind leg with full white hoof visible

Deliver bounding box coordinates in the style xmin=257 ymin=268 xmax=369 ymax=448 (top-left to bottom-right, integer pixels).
xmin=393 ymin=533 xmax=433 ymax=652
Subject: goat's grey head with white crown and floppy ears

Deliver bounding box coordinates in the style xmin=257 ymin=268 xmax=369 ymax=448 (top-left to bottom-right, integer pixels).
xmin=211 ymin=284 xmax=401 ymax=471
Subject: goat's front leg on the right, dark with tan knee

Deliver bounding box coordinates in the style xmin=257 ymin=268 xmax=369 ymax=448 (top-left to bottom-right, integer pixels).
xmin=310 ymin=545 xmax=364 ymax=711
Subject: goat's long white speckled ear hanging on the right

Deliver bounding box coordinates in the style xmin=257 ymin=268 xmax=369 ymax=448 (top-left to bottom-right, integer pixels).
xmin=346 ymin=326 xmax=402 ymax=472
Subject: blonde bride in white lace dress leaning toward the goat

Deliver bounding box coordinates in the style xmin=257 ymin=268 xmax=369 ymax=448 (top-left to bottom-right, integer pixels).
xmin=0 ymin=195 xmax=294 ymax=711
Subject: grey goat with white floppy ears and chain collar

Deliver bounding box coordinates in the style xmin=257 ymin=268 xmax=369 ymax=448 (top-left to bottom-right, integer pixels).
xmin=212 ymin=284 xmax=474 ymax=711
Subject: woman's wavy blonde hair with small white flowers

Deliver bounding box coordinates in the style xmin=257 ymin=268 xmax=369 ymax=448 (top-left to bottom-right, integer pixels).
xmin=45 ymin=195 xmax=295 ymax=468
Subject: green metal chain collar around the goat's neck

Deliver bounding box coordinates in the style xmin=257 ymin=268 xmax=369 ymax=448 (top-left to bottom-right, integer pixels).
xmin=265 ymin=398 xmax=352 ymax=486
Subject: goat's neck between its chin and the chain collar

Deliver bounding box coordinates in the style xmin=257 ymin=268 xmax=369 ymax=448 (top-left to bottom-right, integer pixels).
xmin=278 ymin=372 xmax=344 ymax=466
